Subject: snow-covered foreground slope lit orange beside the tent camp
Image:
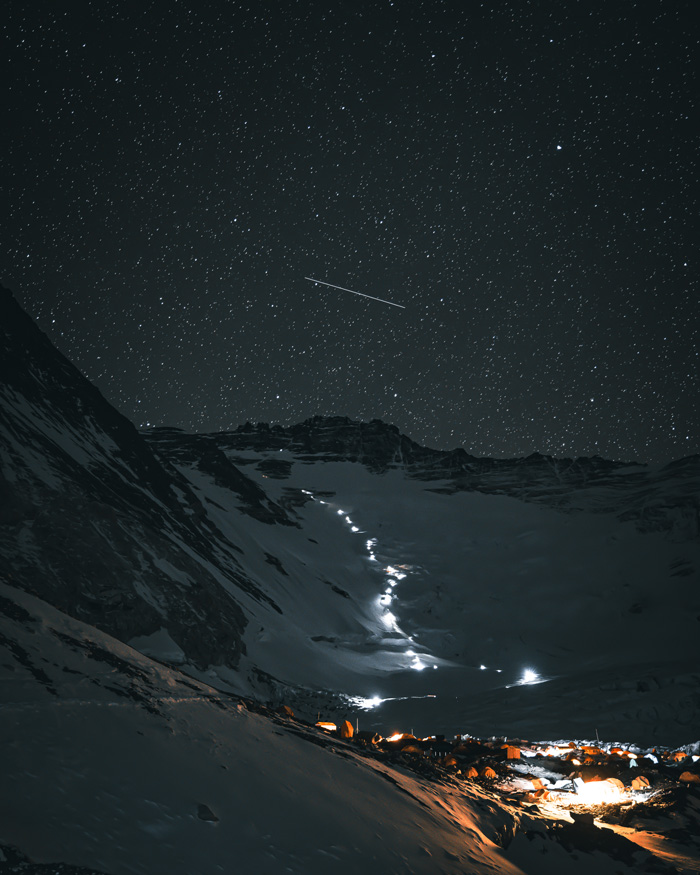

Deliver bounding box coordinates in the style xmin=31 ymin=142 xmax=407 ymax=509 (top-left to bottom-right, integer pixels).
xmin=0 ymin=585 xmax=693 ymax=875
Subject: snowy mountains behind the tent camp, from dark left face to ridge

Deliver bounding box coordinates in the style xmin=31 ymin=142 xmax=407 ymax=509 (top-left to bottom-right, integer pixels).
xmin=0 ymin=280 xmax=700 ymax=743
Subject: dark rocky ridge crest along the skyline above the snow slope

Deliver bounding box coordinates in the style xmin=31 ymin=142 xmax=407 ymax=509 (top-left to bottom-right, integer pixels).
xmin=194 ymin=416 xmax=700 ymax=540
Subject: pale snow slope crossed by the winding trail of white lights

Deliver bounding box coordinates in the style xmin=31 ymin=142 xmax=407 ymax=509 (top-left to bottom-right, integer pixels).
xmin=149 ymin=433 xmax=700 ymax=744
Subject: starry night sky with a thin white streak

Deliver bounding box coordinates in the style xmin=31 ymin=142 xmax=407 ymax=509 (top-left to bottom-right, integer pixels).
xmin=0 ymin=0 xmax=700 ymax=462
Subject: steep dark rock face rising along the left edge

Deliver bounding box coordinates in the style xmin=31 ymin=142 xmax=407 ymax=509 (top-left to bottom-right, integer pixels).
xmin=0 ymin=290 xmax=258 ymax=666
